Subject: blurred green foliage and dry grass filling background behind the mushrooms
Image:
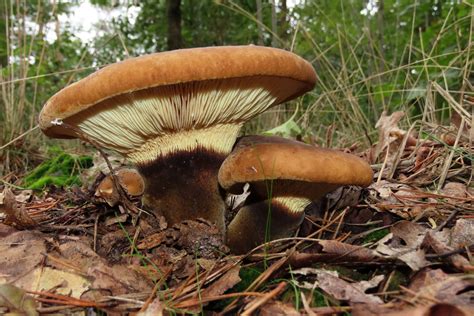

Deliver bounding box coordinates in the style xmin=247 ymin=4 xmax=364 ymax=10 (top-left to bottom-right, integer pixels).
xmin=0 ymin=0 xmax=473 ymax=171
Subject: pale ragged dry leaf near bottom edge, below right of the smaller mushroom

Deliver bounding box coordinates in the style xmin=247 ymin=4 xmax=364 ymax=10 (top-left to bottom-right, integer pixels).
xmin=293 ymin=268 xmax=384 ymax=304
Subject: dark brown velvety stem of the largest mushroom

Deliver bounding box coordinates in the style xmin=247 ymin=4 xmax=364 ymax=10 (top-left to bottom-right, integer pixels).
xmin=138 ymin=148 xmax=225 ymax=232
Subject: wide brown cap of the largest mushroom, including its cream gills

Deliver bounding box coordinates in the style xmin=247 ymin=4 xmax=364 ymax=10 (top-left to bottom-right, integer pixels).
xmin=39 ymin=46 xmax=316 ymax=162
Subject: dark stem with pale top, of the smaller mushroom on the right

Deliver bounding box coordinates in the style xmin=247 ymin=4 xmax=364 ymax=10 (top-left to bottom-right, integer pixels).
xmin=226 ymin=197 xmax=311 ymax=254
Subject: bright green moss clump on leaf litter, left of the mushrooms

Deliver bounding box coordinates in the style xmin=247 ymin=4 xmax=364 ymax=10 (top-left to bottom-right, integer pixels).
xmin=24 ymin=148 xmax=92 ymax=189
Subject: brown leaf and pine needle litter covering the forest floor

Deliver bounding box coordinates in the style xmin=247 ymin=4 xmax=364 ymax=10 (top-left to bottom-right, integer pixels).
xmin=0 ymin=112 xmax=474 ymax=315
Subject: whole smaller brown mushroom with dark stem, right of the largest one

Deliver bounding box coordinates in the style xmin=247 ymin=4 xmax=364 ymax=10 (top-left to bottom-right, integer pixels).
xmin=218 ymin=136 xmax=373 ymax=253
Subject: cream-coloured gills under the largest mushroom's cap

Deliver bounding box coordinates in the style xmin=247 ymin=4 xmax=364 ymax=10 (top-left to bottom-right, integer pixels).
xmin=65 ymin=77 xmax=300 ymax=162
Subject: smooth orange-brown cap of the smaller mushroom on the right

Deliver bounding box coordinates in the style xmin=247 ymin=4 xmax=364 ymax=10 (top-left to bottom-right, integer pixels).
xmin=218 ymin=136 xmax=373 ymax=199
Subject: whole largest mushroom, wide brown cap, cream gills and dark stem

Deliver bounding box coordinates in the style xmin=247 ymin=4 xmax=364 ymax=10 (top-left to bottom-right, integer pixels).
xmin=39 ymin=46 xmax=316 ymax=229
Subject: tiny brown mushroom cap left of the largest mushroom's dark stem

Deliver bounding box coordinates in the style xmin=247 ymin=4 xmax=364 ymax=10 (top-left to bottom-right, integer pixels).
xmin=95 ymin=168 xmax=145 ymax=206
